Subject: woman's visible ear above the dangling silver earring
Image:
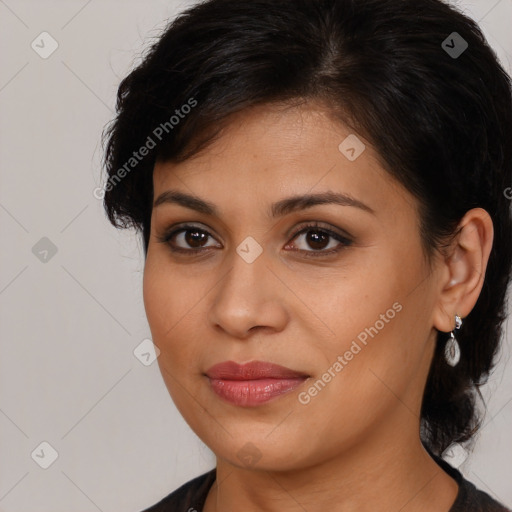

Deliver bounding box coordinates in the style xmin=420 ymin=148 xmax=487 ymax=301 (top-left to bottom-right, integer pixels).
xmin=433 ymin=208 xmax=494 ymax=332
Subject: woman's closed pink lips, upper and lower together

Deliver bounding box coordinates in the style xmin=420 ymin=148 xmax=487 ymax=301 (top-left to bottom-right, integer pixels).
xmin=206 ymin=361 xmax=309 ymax=407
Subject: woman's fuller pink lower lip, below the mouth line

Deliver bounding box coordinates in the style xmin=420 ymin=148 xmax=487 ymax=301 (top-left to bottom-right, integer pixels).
xmin=209 ymin=377 xmax=306 ymax=407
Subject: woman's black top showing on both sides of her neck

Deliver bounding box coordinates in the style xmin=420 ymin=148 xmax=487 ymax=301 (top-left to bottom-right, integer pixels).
xmin=143 ymin=457 xmax=512 ymax=512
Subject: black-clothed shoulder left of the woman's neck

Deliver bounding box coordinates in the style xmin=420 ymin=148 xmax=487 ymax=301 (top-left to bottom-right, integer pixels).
xmin=143 ymin=468 xmax=216 ymax=512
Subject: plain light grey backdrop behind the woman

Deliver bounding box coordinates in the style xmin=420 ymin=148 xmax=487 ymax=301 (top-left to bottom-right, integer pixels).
xmin=0 ymin=0 xmax=512 ymax=512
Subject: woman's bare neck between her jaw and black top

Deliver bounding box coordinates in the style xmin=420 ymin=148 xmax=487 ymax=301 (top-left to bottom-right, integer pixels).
xmin=204 ymin=408 xmax=458 ymax=512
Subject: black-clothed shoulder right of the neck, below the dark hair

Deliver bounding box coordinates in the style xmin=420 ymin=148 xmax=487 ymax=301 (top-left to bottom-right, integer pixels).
xmin=435 ymin=457 xmax=511 ymax=512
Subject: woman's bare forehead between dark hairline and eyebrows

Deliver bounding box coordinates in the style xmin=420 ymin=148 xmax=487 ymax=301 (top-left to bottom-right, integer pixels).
xmin=153 ymin=104 xmax=412 ymax=217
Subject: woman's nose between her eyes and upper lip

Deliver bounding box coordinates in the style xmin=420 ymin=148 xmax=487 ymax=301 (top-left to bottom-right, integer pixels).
xmin=208 ymin=247 xmax=289 ymax=339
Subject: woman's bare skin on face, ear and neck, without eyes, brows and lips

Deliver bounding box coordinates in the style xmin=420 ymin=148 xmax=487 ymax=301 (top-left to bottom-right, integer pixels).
xmin=144 ymin=102 xmax=493 ymax=512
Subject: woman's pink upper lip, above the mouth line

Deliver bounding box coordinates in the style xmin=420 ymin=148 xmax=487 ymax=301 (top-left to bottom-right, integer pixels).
xmin=206 ymin=361 xmax=309 ymax=380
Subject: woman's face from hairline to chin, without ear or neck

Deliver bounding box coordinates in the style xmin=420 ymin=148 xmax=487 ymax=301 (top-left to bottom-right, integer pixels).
xmin=144 ymin=106 xmax=439 ymax=470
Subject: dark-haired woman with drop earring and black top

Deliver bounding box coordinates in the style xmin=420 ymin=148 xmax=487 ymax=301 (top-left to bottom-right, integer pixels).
xmin=101 ymin=0 xmax=512 ymax=512
